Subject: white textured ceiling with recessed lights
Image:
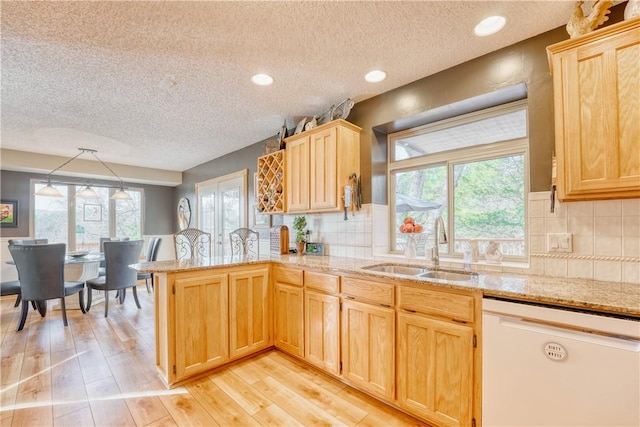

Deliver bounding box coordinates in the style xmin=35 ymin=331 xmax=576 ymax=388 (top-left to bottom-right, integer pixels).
xmin=1 ymin=0 xmax=574 ymax=171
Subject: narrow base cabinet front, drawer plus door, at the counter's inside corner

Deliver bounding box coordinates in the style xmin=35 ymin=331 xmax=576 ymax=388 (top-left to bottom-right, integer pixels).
xmin=274 ymin=266 xmax=304 ymax=357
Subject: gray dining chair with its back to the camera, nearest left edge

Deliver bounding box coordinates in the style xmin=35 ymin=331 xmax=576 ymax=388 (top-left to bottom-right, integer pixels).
xmin=9 ymin=243 xmax=86 ymax=331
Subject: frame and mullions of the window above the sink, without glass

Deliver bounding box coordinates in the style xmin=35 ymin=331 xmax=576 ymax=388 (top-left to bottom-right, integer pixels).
xmin=387 ymin=99 xmax=530 ymax=262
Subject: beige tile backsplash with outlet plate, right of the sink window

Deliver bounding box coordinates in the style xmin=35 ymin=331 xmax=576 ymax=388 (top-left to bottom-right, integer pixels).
xmin=529 ymin=192 xmax=640 ymax=283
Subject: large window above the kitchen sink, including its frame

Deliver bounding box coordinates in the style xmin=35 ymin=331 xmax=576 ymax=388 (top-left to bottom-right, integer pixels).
xmin=389 ymin=101 xmax=528 ymax=261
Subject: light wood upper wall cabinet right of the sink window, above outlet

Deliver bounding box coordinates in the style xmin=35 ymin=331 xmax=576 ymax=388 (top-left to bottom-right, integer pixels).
xmin=547 ymin=18 xmax=640 ymax=201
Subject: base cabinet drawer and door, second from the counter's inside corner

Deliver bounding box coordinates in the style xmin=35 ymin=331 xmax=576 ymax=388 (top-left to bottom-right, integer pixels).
xmin=304 ymin=271 xmax=340 ymax=375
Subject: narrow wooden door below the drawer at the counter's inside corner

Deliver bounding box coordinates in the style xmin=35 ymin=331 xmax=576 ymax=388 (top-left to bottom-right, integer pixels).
xmin=274 ymin=282 xmax=304 ymax=357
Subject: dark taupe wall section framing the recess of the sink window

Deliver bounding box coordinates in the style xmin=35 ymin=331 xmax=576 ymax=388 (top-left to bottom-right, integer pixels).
xmin=347 ymin=3 xmax=626 ymax=204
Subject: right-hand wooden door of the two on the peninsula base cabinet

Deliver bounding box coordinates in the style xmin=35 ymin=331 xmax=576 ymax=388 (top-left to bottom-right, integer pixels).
xmin=229 ymin=267 xmax=271 ymax=358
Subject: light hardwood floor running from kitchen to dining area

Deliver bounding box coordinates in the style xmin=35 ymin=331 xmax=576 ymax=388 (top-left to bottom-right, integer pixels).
xmin=0 ymin=285 xmax=430 ymax=426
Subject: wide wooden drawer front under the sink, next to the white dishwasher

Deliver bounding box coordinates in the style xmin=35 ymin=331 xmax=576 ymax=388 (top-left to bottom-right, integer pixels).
xmin=398 ymin=286 xmax=474 ymax=322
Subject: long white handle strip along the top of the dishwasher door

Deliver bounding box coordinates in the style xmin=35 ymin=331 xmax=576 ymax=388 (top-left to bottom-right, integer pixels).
xmin=485 ymin=313 xmax=640 ymax=353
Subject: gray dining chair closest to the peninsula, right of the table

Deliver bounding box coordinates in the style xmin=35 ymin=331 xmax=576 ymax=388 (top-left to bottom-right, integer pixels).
xmin=87 ymin=240 xmax=144 ymax=317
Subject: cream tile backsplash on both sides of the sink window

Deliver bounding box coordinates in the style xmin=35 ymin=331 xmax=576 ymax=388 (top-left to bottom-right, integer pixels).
xmin=283 ymin=191 xmax=640 ymax=283
